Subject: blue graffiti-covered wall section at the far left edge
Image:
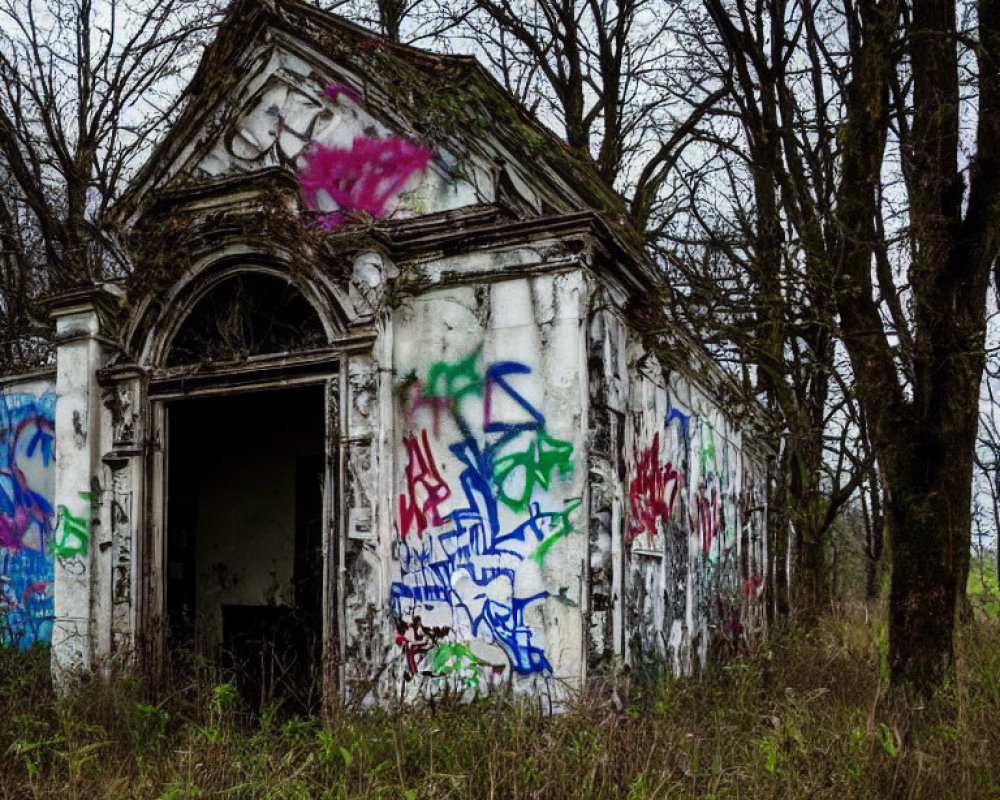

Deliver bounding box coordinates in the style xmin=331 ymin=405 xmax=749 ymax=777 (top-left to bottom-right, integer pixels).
xmin=0 ymin=392 xmax=55 ymax=648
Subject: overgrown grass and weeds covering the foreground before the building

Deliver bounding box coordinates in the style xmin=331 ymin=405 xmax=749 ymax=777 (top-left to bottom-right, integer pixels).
xmin=0 ymin=605 xmax=1000 ymax=800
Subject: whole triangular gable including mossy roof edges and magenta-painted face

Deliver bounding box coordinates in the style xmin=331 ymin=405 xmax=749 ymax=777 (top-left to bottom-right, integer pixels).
xmin=118 ymin=0 xmax=620 ymax=238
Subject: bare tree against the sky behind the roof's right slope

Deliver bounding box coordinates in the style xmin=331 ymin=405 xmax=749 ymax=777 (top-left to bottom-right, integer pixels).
xmin=332 ymin=0 xmax=721 ymax=209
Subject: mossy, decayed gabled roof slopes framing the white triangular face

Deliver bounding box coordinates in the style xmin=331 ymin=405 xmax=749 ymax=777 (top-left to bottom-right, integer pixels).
xmin=114 ymin=0 xmax=638 ymax=234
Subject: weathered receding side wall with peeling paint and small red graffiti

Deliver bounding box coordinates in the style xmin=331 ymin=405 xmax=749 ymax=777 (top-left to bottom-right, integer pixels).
xmin=588 ymin=308 xmax=767 ymax=673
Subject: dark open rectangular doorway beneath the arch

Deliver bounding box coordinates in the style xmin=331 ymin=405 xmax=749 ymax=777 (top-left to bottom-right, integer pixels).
xmin=166 ymin=385 xmax=324 ymax=710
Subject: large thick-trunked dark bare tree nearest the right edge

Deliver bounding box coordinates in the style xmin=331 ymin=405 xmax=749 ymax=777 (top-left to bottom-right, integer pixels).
xmin=705 ymin=0 xmax=1000 ymax=690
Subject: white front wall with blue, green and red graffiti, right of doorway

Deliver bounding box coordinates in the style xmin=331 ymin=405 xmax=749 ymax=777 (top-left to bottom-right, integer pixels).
xmin=346 ymin=272 xmax=587 ymax=696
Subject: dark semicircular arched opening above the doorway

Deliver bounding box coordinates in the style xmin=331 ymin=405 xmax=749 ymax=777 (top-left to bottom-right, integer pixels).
xmin=167 ymin=272 xmax=326 ymax=366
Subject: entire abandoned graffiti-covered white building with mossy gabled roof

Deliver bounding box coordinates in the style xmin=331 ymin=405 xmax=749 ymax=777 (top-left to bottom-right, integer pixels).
xmin=0 ymin=0 xmax=775 ymax=698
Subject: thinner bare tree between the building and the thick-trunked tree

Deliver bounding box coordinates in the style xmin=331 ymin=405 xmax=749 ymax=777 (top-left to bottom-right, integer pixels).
xmin=616 ymin=2 xmax=872 ymax=616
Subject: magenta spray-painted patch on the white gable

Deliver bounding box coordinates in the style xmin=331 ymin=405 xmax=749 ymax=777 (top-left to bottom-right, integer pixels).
xmin=299 ymin=136 xmax=434 ymax=230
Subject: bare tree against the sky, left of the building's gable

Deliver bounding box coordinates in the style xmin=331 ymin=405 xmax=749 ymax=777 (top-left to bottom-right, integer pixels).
xmin=0 ymin=0 xmax=213 ymax=366
